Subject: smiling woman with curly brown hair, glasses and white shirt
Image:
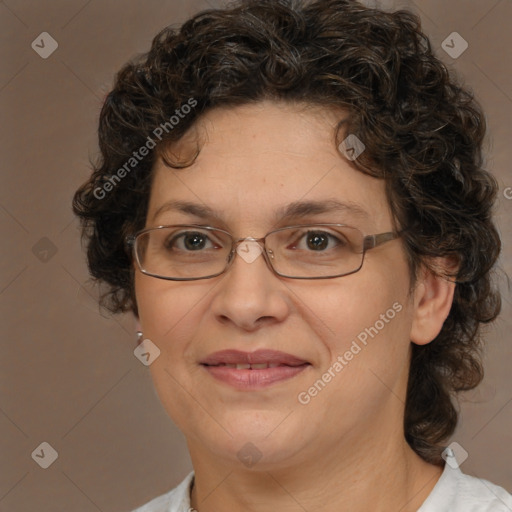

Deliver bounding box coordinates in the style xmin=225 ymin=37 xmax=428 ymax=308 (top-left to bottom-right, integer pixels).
xmin=74 ymin=0 xmax=512 ymax=512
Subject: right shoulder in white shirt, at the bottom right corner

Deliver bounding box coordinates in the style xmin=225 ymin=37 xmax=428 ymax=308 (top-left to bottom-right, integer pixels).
xmin=418 ymin=464 xmax=512 ymax=512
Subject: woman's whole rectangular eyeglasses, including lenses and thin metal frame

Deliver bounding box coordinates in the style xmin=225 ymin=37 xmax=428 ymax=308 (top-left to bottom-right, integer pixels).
xmin=126 ymin=224 xmax=399 ymax=281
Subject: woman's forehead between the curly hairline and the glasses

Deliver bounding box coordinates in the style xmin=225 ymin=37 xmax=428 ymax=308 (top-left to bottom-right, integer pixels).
xmin=148 ymin=102 xmax=391 ymax=229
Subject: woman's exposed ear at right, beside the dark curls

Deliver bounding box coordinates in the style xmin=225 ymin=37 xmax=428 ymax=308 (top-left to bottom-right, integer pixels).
xmin=410 ymin=258 xmax=456 ymax=345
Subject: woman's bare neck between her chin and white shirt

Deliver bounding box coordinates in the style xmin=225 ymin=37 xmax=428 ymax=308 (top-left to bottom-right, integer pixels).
xmin=189 ymin=429 xmax=442 ymax=512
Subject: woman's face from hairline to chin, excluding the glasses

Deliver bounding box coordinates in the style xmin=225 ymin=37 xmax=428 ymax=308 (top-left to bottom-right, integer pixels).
xmin=135 ymin=102 xmax=413 ymax=468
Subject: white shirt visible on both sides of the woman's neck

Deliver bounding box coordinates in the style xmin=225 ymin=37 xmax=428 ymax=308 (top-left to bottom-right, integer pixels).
xmin=133 ymin=464 xmax=512 ymax=512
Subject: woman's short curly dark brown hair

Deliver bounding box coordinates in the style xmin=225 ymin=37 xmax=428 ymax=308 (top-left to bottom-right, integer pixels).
xmin=73 ymin=0 xmax=501 ymax=464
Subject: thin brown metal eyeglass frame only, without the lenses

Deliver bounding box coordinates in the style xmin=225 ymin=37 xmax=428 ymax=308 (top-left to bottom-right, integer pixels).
xmin=125 ymin=223 xmax=401 ymax=281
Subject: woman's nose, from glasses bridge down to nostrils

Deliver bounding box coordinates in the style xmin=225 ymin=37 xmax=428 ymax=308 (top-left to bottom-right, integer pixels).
xmin=207 ymin=238 xmax=290 ymax=331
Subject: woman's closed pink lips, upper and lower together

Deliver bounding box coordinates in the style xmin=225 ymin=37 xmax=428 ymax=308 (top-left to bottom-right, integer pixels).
xmin=200 ymin=350 xmax=311 ymax=391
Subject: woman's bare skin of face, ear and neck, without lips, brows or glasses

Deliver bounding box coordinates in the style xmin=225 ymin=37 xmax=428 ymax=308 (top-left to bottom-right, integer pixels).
xmin=135 ymin=102 xmax=454 ymax=512
